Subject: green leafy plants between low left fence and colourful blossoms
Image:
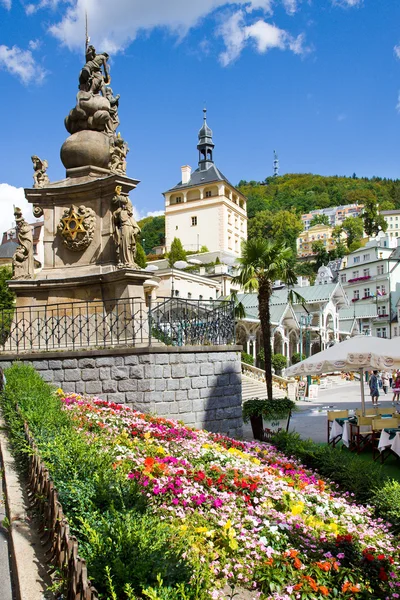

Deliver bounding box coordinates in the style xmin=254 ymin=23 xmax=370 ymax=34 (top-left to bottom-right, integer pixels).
xmin=1 ymin=363 xmax=206 ymax=600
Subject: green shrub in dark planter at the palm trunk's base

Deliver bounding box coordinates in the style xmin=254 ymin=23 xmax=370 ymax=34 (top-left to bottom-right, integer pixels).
xmin=243 ymin=398 xmax=296 ymax=441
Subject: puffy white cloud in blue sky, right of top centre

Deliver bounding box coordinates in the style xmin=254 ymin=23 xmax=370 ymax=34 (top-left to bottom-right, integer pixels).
xmin=219 ymin=11 xmax=308 ymax=66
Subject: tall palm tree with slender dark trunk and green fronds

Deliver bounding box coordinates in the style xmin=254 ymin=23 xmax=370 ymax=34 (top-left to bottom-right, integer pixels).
xmin=233 ymin=238 xmax=303 ymax=400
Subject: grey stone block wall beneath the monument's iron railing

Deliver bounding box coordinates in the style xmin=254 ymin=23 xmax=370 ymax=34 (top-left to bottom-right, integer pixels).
xmin=0 ymin=346 xmax=243 ymax=437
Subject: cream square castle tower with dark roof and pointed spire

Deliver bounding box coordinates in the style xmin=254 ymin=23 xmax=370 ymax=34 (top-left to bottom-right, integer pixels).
xmin=164 ymin=110 xmax=247 ymax=256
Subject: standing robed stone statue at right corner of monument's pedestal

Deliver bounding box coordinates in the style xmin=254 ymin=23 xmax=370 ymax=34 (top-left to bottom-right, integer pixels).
xmin=112 ymin=185 xmax=140 ymax=268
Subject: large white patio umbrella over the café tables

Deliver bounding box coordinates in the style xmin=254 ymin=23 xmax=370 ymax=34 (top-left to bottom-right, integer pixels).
xmin=285 ymin=335 xmax=394 ymax=414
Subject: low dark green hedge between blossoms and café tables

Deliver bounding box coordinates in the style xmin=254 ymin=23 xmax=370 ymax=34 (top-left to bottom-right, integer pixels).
xmin=273 ymin=432 xmax=386 ymax=506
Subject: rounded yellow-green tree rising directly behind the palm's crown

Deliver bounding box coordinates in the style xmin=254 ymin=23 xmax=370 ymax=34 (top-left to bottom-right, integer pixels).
xmin=248 ymin=210 xmax=304 ymax=251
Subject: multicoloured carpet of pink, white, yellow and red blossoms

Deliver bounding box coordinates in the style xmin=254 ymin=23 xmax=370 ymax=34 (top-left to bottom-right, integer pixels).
xmin=59 ymin=395 xmax=400 ymax=599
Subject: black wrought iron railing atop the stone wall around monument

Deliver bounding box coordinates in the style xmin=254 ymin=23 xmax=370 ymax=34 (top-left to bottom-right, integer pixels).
xmin=0 ymin=298 xmax=235 ymax=354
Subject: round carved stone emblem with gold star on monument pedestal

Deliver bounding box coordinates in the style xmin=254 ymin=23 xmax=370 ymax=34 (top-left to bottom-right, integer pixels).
xmin=57 ymin=205 xmax=96 ymax=252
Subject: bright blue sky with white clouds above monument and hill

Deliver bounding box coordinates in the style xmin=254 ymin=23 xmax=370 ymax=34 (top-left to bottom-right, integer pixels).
xmin=0 ymin=0 xmax=400 ymax=230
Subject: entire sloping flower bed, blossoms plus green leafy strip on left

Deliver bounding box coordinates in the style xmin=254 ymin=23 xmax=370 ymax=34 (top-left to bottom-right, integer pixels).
xmin=2 ymin=365 xmax=400 ymax=600
